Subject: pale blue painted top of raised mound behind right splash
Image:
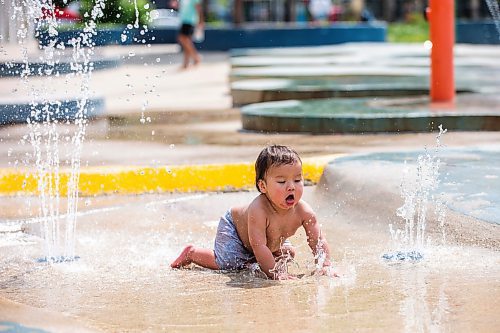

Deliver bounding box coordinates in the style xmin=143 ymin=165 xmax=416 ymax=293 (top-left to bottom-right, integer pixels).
xmin=333 ymin=146 xmax=500 ymax=224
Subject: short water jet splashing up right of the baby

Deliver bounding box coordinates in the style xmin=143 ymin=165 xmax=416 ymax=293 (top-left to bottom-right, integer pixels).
xmin=383 ymin=125 xmax=447 ymax=261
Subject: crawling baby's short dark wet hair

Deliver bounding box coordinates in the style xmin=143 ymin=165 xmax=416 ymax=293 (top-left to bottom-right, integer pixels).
xmin=255 ymin=145 xmax=302 ymax=192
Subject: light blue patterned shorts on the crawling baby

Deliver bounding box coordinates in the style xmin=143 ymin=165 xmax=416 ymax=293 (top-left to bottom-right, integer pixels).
xmin=214 ymin=210 xmax=255 ymax=270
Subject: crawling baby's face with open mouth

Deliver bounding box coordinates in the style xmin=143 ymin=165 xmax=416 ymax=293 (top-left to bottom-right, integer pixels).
xmin=263 ymin=162 xmax=304 ymax=210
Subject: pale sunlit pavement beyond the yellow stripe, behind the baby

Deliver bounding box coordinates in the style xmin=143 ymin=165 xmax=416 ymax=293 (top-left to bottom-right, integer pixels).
xmin=0 ymin=44 xmax=499 ymax=189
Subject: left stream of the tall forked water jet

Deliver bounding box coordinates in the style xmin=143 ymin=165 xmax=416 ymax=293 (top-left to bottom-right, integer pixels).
xmin=12 ymin=0 xmax=62 ymax=258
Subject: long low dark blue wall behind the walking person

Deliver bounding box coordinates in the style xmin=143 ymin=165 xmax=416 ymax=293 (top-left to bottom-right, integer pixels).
xmin=38 ymin=23 xmax=387 ymax=51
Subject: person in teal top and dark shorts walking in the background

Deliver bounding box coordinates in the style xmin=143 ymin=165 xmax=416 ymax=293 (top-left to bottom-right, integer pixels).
xmin=177 ymin=0 xmax=204 ymax=68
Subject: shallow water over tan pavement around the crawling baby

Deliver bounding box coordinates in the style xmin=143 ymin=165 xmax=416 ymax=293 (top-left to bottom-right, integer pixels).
xmin=0 ymin=184 xmax=500 ymax=332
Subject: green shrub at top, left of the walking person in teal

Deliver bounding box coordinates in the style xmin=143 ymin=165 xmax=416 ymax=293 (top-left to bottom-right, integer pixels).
xmin=80 ymin=0 xmax=153 ymax=26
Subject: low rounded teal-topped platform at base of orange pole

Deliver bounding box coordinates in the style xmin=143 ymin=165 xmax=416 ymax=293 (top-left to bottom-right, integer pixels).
xmin=241 ymin=94 xmax=500 ymax=134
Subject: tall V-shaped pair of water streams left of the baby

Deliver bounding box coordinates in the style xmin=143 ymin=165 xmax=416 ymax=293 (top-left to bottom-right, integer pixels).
xmin=12 ymin=0 xmax=105 ymax=262
